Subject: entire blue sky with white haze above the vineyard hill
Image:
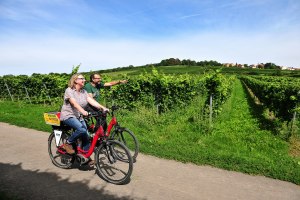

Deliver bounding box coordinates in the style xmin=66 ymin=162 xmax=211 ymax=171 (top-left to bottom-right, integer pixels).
xmin=0 ymin=0 xmax=300 ymax=76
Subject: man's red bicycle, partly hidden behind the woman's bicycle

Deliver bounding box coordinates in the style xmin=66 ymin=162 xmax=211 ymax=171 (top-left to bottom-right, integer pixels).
xmin=85 ymin=106 xmax=139 ymax=162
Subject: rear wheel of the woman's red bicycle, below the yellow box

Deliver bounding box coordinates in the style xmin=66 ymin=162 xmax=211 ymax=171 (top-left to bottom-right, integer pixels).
xmin=48 ymin=132 xmax=75 ymax=169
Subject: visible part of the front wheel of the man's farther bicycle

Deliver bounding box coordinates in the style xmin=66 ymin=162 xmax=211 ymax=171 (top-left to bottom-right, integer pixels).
xmin=111 ymin=128 xmax=140 ymax=162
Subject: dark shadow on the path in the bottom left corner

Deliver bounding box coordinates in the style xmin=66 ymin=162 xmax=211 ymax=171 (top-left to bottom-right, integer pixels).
xmin=0 ymin=163 xmax=143 ymax=200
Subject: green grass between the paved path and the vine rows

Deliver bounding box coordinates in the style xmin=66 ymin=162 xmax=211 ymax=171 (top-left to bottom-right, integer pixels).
xmin=0 ymin=80 xmax=300 ymax=185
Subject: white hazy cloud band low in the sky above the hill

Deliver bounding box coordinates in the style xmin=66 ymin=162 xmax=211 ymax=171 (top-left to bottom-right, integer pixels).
xmin=0 ymin=28 xmax=300 ymax=75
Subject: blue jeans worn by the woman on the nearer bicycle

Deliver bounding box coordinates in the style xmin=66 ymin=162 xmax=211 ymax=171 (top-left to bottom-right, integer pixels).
xmin=63 ymin=117 xmax=90 ymax=151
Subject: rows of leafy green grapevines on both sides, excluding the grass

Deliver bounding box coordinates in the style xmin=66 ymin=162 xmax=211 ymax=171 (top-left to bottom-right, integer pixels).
xmin=0 ymin=66 xmax=300 ymax=129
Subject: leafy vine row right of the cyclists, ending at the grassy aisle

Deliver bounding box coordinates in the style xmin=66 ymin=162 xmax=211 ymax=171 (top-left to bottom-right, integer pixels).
xmin=101 ymin=68 xmax=234 ymax=113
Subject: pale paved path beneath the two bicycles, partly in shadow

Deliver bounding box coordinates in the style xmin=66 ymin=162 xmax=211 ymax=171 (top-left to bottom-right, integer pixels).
xmin=0 ymin=122 xmax=300 ymax=200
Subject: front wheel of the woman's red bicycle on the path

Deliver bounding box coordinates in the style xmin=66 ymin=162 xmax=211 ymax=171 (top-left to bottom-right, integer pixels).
xmin=95 ymin=140 xmax=133 ymax=185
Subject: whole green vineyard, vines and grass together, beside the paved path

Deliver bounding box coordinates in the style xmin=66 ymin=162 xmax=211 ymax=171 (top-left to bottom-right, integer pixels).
xmin=0 ymin=66 xmax=300 ymax=184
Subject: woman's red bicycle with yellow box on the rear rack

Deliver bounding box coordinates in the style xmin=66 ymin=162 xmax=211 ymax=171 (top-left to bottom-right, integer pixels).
xmin=44 ymin=112 xmax=133 ymax=185
